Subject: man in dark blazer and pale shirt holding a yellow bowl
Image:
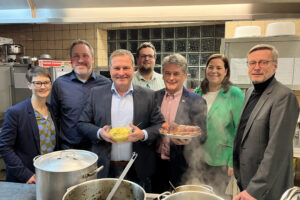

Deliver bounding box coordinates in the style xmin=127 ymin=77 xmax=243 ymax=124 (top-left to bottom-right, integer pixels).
xmin=78 ymin=50 xmax=164 ymax=191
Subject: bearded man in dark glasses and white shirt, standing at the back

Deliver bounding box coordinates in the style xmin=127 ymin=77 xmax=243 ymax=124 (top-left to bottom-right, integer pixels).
xmin=132 ymin=42 xmax=165 ymax=91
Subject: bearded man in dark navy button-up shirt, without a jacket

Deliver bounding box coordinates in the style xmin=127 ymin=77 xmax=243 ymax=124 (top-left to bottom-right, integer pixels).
xmin=51 ymin=40 xmax=111 ymax=150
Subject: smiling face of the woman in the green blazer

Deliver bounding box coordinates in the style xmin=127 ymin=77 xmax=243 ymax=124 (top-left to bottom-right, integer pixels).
xmin=205 ymin=58 xmax=227 ymax=87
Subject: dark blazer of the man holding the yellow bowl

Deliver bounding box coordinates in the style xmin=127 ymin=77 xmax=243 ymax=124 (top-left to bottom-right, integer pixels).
xmin=77 ymin=84 xmax=164 ymax=181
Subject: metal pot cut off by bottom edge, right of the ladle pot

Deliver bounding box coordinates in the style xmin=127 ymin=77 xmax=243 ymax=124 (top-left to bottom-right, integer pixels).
xmin=160 ymin=191 xmax=224 ymax=200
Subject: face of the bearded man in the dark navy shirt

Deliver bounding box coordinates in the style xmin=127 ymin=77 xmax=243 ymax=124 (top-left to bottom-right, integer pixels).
xmin=71 ymin=44 xmax=94 ymax=80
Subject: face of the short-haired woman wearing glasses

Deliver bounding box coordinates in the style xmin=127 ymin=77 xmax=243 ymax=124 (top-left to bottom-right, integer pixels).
xmin=28 ymin=76 xmax=51 ymax=98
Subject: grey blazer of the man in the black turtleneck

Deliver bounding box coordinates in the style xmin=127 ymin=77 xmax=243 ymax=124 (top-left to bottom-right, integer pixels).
xmin=233 ymin=78 xmax=299 ymax=200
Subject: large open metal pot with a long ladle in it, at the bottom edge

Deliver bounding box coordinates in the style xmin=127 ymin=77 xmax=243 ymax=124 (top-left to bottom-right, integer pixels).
xmin=63 ymin=178 xmax=146 ymax=200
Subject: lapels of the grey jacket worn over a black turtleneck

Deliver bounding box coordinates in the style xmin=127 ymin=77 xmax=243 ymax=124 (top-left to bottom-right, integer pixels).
xmin=241 ymin=79 xmax=276 ymax=143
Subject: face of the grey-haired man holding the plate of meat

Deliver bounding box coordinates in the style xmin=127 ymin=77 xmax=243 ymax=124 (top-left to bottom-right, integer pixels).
xmin=163 ymin=64 xmax=187 ymax=94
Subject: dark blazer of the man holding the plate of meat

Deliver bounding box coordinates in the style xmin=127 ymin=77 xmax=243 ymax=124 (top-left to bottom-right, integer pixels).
xmin=155 ymin=88 xmax=207 ymax=185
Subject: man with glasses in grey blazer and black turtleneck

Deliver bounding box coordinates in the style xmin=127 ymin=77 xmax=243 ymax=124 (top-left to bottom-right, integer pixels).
xmin=233 ymin=45 xmax=299 ymax=200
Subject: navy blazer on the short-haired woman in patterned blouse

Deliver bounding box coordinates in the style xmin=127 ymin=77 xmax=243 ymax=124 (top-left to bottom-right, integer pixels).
xmin=0 ymin=97 xmax=57 ymax=183
